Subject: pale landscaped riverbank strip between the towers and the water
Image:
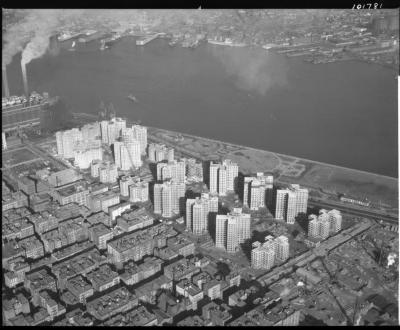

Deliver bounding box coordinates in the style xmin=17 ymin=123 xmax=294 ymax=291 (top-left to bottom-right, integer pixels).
xmin=70 ymin=113 xmax=398 ymax=214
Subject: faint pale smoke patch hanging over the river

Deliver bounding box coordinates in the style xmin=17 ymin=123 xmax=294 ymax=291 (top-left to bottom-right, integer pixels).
xmin=212 ymin=46 xmax=287 ymax=95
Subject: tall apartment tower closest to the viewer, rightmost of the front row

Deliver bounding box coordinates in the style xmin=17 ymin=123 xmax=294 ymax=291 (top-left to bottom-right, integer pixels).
xmin=215 ymin=208 xmax=251 ymax=253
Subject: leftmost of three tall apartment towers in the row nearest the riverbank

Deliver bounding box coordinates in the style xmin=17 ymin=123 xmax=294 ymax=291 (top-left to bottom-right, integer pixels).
xmin=208 ymin=159 xmax=239 ymax=196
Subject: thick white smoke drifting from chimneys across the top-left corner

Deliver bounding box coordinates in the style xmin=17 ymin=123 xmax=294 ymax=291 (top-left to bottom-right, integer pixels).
xmin=2 ymin=9 xmax=219 ymax=67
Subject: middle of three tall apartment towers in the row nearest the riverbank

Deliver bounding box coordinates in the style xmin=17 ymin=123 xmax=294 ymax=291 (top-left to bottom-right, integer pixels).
xmin=243 ymin=173 xmax=274 ymax=210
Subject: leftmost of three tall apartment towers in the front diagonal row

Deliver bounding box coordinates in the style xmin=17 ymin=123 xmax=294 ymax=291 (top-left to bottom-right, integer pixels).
xmin=154 ymin=180 xmax=186 ymax=218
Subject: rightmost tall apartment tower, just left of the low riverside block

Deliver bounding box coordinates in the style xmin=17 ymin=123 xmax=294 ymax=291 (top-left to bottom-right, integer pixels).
xmin=275 ymin=184 xmax=308 ymax=224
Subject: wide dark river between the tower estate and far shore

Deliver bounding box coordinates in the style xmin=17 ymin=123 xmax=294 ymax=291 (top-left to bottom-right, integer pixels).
xmin=4 ymin=37 xmax=398 ymax=177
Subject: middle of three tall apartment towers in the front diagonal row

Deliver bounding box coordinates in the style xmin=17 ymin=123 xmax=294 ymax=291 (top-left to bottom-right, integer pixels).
xmin=186 ymin=193 xmax=218 ymax=235
